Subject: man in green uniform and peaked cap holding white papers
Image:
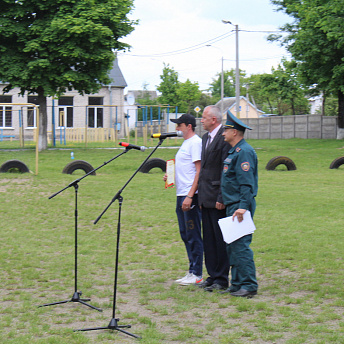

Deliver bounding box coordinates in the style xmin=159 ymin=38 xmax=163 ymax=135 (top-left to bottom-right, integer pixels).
xmin=221 ymin=110 xmax=258 ymax=297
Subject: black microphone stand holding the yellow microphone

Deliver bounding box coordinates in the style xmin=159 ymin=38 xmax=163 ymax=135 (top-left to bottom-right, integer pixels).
xmin=74 ymin=138 xmax=164 ymax=338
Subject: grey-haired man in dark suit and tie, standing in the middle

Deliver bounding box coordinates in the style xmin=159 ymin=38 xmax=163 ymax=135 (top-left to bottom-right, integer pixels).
xmin=198 ymin=105 xmax=230 ymax=291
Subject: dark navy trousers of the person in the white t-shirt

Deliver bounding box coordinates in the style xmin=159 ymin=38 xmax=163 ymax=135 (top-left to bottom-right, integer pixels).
xmin=176 ymin=194 xmax=203 ymax=276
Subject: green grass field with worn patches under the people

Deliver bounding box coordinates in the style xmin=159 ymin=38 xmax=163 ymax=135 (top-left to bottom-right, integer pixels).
xmin=0 ymin=139 xmax=344 ymax=344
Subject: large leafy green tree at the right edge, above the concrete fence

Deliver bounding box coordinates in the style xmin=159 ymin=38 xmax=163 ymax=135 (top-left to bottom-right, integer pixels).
xmin=270 ymin=0 xmax=344 ymax=138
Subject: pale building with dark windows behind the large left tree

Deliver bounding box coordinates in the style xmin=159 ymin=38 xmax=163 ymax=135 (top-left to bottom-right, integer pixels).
xmin=0 ymin=59 xmax=127 ymax=137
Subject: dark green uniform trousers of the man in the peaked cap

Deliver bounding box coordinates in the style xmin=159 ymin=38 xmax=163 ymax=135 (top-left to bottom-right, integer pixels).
xmin=226 ymin=201 xmax=258 ymax=291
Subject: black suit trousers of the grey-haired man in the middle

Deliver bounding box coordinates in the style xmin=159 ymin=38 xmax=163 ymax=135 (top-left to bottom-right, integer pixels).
xmin=202 ymin=207 xmax=229 ymax=288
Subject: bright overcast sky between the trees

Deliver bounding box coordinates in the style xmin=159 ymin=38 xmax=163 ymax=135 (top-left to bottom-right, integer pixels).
xmin=118 ymin=0 xmax=291 ymax=93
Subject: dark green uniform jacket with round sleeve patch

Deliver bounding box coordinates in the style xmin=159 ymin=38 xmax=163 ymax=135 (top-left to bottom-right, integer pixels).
xmin=221 ymin=139 xmax=258 ymax=211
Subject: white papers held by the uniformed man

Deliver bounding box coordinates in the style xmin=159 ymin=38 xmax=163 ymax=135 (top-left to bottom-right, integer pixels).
xmin=219 ymin=210 xmax=256 ymax=244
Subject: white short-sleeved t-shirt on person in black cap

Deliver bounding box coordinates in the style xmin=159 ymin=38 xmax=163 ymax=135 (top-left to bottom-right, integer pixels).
xmin=175 ymin=134 xmax=202 ymax=196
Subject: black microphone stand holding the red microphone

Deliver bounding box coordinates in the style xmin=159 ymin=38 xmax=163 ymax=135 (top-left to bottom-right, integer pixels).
xmin=38 ymin=149 xmax=128 ymax=312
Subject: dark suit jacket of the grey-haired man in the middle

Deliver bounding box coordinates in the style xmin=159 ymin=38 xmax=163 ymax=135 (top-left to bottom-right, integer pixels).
xmin=198 ymin=127 xmax=231 ymax=208
